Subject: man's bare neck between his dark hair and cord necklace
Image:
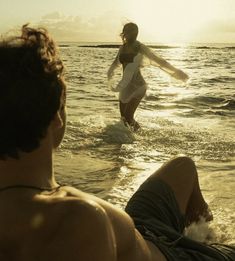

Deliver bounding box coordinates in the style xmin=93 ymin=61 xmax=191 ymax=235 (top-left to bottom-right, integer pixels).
xmin=0 ymin=138 xmax=57 ymax=188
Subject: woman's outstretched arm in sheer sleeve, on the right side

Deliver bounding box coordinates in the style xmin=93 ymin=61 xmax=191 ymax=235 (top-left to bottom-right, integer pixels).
xmin=141 ymin=43 xmax=189 ymax=81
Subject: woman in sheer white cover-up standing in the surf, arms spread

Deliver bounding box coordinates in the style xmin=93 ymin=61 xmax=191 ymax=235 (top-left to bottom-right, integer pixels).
xmin=108 ymin=23 xmax=188 ymax=131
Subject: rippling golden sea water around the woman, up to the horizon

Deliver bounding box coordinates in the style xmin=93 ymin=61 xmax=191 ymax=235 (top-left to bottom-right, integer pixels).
xmin=55 ymin=43 xmax=235 ymax=244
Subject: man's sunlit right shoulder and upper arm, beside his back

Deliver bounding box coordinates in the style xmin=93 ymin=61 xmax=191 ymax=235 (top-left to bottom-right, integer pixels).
xmin=54 ymin=187 xmax=166 ymax=261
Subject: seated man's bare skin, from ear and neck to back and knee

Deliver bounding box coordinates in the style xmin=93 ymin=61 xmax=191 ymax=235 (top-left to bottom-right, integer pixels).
xmin=0 ymin=105 xmax=211 ymax=261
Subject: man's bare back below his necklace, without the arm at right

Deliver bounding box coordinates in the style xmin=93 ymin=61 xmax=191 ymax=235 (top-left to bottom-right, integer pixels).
xmin=0 ymin=187 xmax=116 ymax=261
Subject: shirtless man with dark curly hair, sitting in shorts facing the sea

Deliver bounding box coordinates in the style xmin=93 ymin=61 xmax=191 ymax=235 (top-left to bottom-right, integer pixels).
xmin=0 ymin=25 xmax=235 ymax=261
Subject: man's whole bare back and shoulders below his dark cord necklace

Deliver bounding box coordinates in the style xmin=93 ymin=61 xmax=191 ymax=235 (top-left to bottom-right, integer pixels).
xmin=0 ymin=187 xmax=166 ymax=261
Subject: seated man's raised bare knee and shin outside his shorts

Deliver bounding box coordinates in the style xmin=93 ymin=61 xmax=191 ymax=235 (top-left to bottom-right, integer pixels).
xmin=151 ymin=157 xmax=213 ymax=225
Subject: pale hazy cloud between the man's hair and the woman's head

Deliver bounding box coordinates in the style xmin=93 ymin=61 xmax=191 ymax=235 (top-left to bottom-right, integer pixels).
xmin=36 ymin=12 xmax=125 ymax=42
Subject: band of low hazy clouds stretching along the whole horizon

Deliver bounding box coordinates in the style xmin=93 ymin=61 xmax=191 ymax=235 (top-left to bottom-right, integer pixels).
xmin=0 ymin=10 xmax=235 ymax=43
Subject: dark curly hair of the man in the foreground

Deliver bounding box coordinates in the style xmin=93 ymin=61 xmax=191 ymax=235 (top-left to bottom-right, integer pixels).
xmin=0 ymin=25 xmax=65 ymax=159
